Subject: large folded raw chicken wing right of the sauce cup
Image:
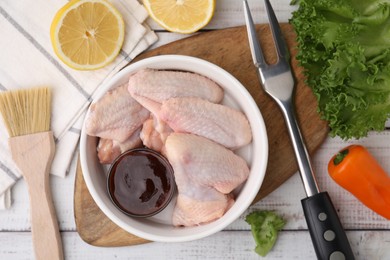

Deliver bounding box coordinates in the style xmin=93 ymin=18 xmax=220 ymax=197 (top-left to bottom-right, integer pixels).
xmin=165 ymin=133 xmax=249 ymax=226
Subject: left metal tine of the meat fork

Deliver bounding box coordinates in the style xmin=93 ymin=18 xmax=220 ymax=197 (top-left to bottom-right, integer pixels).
xmin=243 ymin=0 xmax=267 ymax=68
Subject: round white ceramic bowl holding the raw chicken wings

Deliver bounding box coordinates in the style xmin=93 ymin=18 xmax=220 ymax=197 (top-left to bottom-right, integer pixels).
xmin=80 ymin=55 xmax=268 ymax=242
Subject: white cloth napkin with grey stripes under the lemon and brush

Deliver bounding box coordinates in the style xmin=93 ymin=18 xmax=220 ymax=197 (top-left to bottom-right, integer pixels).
xmin=0 ymin=0 xmax=157 ymax=209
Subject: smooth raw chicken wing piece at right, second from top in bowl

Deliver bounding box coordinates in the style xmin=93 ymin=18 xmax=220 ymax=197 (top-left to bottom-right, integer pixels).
xmin=158 ymin=98 xmax=252 ymax=149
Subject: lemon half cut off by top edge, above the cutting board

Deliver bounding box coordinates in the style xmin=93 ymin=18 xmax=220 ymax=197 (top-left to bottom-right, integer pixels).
xmin=143 ymin=0 xmax=215 ymax=33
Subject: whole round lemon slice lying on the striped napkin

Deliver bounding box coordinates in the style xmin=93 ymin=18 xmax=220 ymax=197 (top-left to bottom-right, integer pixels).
xmin=50 ymin=0 xmax=125 ymax=70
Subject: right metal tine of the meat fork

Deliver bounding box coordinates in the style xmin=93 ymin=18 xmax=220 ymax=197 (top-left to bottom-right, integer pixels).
xmin=264 ymin=0 xmax=290 ymax=59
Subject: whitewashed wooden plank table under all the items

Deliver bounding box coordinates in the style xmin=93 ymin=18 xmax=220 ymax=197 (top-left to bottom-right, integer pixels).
xmin=0 ymin=0 xmax=390 ymax=260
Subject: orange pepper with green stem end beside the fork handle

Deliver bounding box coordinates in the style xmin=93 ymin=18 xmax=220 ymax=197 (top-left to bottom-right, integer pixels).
xmin=328 ymin=145 xmax=390 ymax=219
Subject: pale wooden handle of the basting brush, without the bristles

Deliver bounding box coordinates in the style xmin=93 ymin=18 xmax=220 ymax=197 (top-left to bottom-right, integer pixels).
xmin=9 ymin=132 xmax=63 ymax=260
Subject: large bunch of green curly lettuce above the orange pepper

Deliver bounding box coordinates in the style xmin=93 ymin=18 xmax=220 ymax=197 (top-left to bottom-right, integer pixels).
xmin=290 ymin=0 xmax=390 ymax=139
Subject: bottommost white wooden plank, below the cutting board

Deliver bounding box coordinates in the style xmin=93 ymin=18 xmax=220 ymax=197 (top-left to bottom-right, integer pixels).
xmin=0 ymin=230 xmax=390 ymax=260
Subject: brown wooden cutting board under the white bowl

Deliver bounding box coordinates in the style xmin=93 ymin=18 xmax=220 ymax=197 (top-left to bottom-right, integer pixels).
xmin=74 ymin=24 xmax=328 ymax=247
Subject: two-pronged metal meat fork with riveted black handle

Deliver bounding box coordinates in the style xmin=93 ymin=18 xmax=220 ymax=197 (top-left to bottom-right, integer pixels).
xmin=243 ymin=0 xmax=354 ymax=260
